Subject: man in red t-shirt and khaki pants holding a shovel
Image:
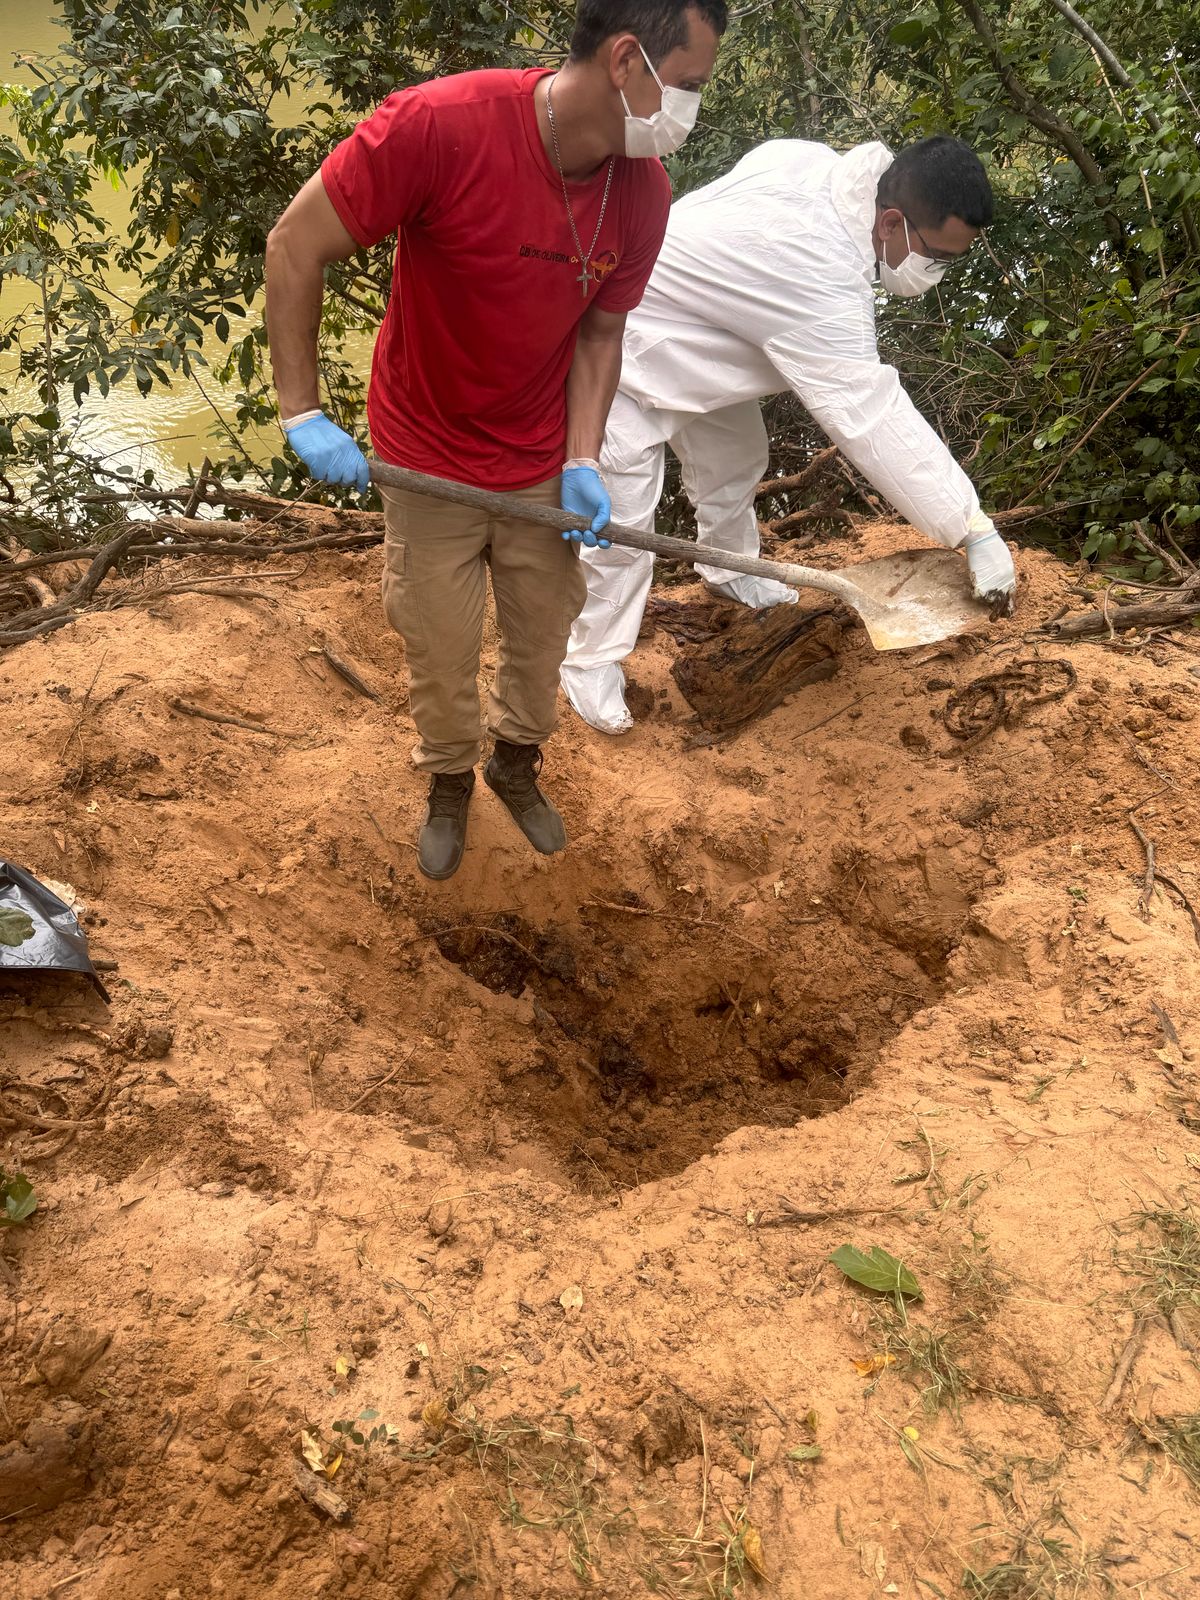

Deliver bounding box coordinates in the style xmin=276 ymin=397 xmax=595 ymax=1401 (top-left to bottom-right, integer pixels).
xmin=267 ymin=0 xmax=726 ymax=878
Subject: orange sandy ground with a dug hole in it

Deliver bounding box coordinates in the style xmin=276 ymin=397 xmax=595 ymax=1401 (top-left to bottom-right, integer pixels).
xmin=0 ymin=525 xmax=1200 ymax=1600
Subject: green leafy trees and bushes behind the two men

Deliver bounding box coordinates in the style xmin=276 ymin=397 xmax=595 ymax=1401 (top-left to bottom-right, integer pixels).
xmin=0 ymin=0 xmax=1200 ymax=562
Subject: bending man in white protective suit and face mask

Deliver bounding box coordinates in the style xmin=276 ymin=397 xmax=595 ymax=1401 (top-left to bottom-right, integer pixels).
xmin=562 ymin=136 xmax=1016 ymax=733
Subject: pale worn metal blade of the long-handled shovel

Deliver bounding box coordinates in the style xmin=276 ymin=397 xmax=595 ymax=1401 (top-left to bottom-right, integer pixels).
xmin=840 ymin=549 xmax=987 ymax=650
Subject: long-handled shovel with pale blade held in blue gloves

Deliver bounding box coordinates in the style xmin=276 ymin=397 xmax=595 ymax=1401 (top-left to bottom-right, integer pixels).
xmin=371 ymin=459 xmax=987 ymax=650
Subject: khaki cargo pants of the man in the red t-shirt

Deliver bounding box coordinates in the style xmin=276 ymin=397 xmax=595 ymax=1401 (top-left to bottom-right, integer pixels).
xmin=379 ymin=477 xmax=587 ymax=773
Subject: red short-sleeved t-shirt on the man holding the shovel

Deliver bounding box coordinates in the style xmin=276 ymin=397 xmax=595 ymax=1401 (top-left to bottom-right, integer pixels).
xmin=322 ymin=67 xmax=670 ymax=491
